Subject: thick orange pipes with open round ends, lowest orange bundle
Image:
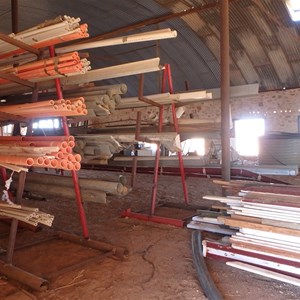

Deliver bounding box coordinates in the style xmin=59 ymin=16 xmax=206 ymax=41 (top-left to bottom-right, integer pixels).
xmin=0 ymin=136 xmax=81 ymax=171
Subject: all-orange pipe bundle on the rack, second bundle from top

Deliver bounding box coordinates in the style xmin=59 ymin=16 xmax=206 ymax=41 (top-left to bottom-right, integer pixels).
xmin=0 ymin=52 xmax=91 ymax=87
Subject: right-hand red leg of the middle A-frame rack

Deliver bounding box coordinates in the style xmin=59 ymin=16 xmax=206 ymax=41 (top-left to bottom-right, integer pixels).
xmin=162 ymin=64 xmax=189 ymax=204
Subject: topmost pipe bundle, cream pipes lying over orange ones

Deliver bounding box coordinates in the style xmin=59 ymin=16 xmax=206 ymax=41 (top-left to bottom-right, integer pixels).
xmin=0 ymin=16 xmax=89 ymax=59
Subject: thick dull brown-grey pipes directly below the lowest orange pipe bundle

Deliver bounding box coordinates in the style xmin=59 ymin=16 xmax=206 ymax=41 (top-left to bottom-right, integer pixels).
xmin=12 ymin=172 xmax=129 ymax=203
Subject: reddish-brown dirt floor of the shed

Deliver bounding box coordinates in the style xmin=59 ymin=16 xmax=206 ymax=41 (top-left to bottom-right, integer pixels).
xmin=0 ymin=171 xmax=300 ymax=300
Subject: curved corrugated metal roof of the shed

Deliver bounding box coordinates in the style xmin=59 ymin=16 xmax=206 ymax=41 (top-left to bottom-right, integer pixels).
xmin=0 ymin=0 xmax=300 ymax=95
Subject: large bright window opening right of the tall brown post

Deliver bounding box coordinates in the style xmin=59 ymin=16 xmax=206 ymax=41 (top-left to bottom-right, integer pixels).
xmin=234 ymin=119 xmax=265 ymax=156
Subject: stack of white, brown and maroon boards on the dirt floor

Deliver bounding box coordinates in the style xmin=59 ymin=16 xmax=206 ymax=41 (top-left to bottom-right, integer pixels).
xmin=196 ymin=182 xmax=300 ymax=286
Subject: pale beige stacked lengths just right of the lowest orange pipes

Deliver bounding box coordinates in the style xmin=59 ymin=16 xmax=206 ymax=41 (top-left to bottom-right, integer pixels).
xmin=74 ymin=132 xmax=181 ymax=164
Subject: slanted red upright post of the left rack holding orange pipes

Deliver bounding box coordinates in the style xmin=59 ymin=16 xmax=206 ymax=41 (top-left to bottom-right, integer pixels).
xmin=49 ymin=46 xmax=89 ymax=239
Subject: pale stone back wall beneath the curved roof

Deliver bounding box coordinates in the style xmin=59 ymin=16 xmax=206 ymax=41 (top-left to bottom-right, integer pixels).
xmin=95 ymin=89 xmax=300 ymax=133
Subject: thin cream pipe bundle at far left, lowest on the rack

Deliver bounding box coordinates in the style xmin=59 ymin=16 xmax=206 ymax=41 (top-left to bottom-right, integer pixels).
xmin=0 ymin=203 xmax=54 ymax=226
